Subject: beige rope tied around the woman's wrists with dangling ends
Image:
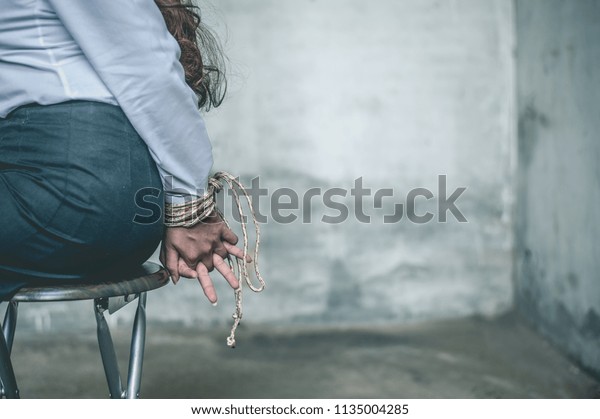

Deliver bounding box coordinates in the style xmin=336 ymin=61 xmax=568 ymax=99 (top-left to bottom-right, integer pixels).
xmin=165 ymin=172 xmax=265 ymax=348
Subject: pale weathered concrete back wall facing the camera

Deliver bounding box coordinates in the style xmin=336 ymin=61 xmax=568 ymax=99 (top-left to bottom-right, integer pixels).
xmin=5 ymin=0 xmax=516 ymax=333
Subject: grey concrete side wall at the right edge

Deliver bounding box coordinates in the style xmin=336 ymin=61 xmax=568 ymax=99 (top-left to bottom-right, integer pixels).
xmin=516 ymin=0 xmax=600 ymax=373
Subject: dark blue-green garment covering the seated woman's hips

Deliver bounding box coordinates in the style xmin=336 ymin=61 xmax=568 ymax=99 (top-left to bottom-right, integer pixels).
xmin=0 ymin=101 xmax=163 ymax=301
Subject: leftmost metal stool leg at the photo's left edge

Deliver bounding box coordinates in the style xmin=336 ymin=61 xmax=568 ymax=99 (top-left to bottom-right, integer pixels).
xmin=0 ymin=301 xmax=19 ymax=399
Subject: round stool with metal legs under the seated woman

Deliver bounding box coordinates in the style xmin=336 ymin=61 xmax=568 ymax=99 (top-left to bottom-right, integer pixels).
xmin=0 ymin=262 xmax=169 ymax=399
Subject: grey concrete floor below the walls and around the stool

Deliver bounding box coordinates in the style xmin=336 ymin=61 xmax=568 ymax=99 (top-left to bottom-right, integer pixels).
xmin=5 ymin=314 xmax=600 ymax=398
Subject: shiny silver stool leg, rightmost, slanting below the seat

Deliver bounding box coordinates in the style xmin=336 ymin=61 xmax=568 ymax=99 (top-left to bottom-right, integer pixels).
xmin=126 ymin=292 xmax=146 ymax=399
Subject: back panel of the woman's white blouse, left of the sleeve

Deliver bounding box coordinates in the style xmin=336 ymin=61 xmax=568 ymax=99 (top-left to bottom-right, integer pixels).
xmin=0 ymin=0 xmax=117 ymax=117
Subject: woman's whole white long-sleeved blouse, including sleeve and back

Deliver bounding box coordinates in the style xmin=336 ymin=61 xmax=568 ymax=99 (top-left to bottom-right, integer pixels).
xmin=0 ymin=0 xmax=212 ymax=199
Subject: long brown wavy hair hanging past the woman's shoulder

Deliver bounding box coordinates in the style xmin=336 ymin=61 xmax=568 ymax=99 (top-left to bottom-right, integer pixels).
xmin=155 ymin=0 xmax=227 ymax=111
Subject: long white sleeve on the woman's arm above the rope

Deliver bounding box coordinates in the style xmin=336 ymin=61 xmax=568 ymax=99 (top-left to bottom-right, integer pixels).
xmin=49 ymin=0 xmax=212 ymax=197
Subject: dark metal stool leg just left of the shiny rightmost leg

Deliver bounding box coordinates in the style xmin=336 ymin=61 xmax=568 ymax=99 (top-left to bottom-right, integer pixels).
xmin=94 ymin=298 xmax=123 ymax=399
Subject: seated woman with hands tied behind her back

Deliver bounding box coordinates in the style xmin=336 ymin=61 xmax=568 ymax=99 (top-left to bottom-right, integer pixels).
xmin=0 ymin=0 xmax=243 ymax=303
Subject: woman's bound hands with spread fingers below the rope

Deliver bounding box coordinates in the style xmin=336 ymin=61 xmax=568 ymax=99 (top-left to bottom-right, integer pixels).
xmin=160 ymin=214 xmax=252 ymax=304
